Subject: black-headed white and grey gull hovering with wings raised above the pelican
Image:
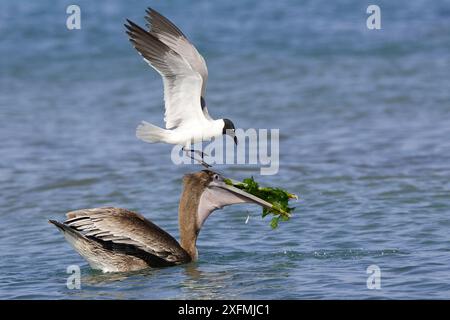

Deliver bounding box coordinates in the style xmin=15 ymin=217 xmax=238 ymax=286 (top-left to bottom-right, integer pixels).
xmin=125 ymin=8 xmax=237 ymax=164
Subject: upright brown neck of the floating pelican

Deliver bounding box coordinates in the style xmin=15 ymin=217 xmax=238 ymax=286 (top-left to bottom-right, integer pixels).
xmin=178 ymin=182 xmax=202 ymax=261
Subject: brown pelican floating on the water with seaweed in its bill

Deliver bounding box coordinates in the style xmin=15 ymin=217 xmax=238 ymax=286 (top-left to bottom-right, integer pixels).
xmin=49 ymin=170 xmax=272 ymax=272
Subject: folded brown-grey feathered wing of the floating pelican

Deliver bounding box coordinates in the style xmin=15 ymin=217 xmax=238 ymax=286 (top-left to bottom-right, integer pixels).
xmin=64 ymin=207 xmax=189 ymax=263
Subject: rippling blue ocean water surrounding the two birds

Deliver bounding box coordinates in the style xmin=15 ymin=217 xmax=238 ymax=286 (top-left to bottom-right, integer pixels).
xmin=0 ymin=0 xmax=450 ymax=299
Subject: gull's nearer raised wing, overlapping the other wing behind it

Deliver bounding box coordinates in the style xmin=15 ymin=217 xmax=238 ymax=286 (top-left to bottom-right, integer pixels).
xmin=125 ymin=20 xmax=205 ymax=129
